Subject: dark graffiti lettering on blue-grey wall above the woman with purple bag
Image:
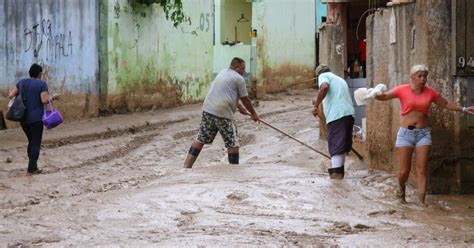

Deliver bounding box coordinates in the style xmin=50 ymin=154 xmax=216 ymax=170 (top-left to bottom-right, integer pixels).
xmin=24 ymin=19 xmax=73 ymax=62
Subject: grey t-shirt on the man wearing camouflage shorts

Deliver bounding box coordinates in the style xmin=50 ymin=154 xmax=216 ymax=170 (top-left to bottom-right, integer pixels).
xmin=202 ymin=69 xmax=248 ymax=120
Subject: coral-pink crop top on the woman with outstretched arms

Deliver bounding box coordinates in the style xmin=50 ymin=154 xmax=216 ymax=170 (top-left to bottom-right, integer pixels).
xmin=393 ymin=84 xmax=439 ymax=116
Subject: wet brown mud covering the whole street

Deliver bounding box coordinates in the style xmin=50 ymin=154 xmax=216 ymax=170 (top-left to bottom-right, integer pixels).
xmin=0 ymin=91 xmax=474 ymax=247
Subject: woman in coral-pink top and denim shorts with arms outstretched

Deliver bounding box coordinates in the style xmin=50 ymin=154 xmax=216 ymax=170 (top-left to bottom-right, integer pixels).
xmin=375 ymin=65 xmax=474 ymax=205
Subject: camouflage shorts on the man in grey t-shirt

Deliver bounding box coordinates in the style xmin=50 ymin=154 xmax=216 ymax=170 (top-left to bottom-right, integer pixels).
xmin=197 ymin=112 xmax=240 ymax=148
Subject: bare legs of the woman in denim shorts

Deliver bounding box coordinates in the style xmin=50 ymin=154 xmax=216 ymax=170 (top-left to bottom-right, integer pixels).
xmin=397 ymin=146 xmax=430 ymax=205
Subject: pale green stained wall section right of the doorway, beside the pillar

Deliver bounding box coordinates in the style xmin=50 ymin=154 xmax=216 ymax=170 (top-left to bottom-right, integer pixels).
xmin=252 ymin=0 xmax=316 ymax=94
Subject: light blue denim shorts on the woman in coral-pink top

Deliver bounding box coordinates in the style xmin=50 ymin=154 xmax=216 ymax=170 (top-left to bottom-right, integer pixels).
xmin=395 ymin=127 xmax=431 ymax=147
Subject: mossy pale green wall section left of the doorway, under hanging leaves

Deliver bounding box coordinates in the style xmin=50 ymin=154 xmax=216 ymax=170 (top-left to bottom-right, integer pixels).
xmin=105 ymin=0 xmax=214 ymax=112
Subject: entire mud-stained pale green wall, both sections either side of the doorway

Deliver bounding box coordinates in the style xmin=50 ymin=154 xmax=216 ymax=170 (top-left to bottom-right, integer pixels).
xmin=100 ymin=0 xmax=316 ymax=112
